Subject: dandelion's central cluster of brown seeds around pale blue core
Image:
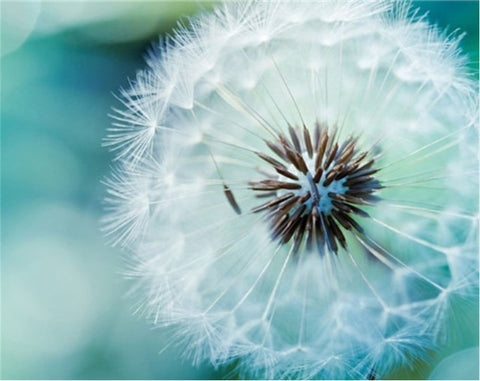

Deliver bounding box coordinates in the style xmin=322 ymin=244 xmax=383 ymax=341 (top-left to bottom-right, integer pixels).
xmin=249 ymin=123 xmax=382 ymax=255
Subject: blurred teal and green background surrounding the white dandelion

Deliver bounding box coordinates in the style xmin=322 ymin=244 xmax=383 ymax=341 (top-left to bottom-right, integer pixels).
xmin=0 ymin=1 xmax=478 ymax=379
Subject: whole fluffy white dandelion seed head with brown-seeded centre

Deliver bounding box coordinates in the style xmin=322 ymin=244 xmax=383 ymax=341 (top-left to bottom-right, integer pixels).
xmin=105 ymin=0 xmax=478 ymax=379
